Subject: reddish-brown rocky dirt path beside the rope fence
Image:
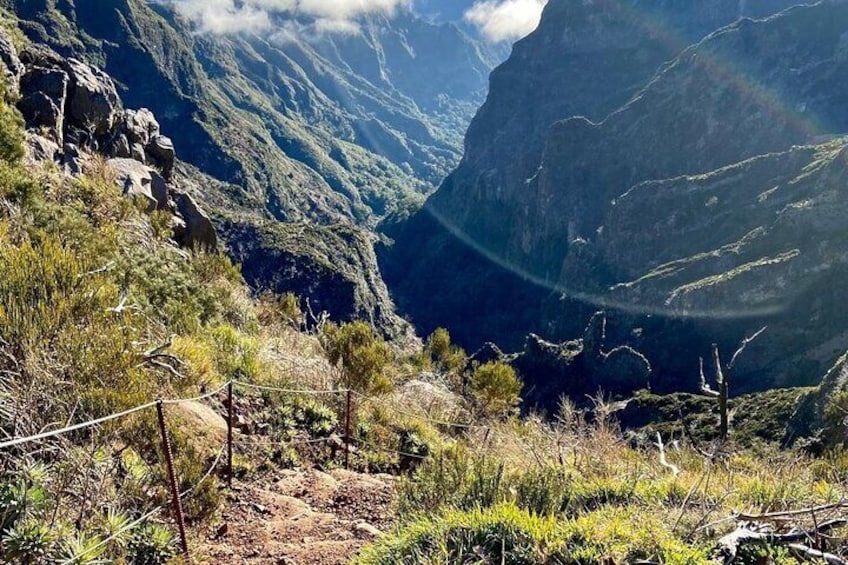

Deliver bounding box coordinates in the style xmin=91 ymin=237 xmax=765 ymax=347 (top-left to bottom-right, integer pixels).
xmin=195 ymin=469 xmax=393 ymax=565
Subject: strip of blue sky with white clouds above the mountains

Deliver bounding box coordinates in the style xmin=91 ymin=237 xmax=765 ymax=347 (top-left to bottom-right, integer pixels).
xmin=164 ymin=0 xmax=547 ymax=42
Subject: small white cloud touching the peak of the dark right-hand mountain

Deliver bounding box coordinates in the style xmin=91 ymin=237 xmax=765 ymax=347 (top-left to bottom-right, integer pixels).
xmin=465 ymin=0 xmax=547 ymax=41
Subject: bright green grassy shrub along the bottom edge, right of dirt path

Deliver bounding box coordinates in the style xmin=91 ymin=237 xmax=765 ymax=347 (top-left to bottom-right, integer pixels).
xmin=357 ymin=505 xmax=709 ymax=565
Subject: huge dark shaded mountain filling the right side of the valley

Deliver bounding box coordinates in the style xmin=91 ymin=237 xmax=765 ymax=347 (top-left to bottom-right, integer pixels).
xmin=383 ymin=0 xmax=848 ymax=391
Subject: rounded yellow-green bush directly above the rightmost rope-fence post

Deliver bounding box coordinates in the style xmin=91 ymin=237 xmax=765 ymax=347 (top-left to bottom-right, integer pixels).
xmin=321 ymin=322 xmax=392 ymax=393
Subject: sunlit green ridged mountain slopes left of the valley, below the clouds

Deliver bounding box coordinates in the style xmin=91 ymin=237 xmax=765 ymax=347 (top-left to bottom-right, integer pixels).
xmin=3 ymin=0 xmax=501 ymax=333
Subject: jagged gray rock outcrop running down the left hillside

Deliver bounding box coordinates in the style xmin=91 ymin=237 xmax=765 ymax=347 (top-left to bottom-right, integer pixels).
xmin=5 ymin=36 xmax=218 ymax=250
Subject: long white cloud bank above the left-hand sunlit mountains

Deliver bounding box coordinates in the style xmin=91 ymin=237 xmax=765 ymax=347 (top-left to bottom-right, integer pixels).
xmin=163 ymin=0 xmax=410 ymax=34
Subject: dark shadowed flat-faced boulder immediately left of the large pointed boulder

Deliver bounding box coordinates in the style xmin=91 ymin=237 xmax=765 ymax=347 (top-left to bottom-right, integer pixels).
xmin=18 ymin=67 xmax=69 ymax=143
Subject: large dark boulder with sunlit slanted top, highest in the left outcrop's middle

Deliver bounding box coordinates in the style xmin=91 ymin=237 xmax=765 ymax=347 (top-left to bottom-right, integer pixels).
xmin=65 ymin=58 xmax=121 ymax=136
